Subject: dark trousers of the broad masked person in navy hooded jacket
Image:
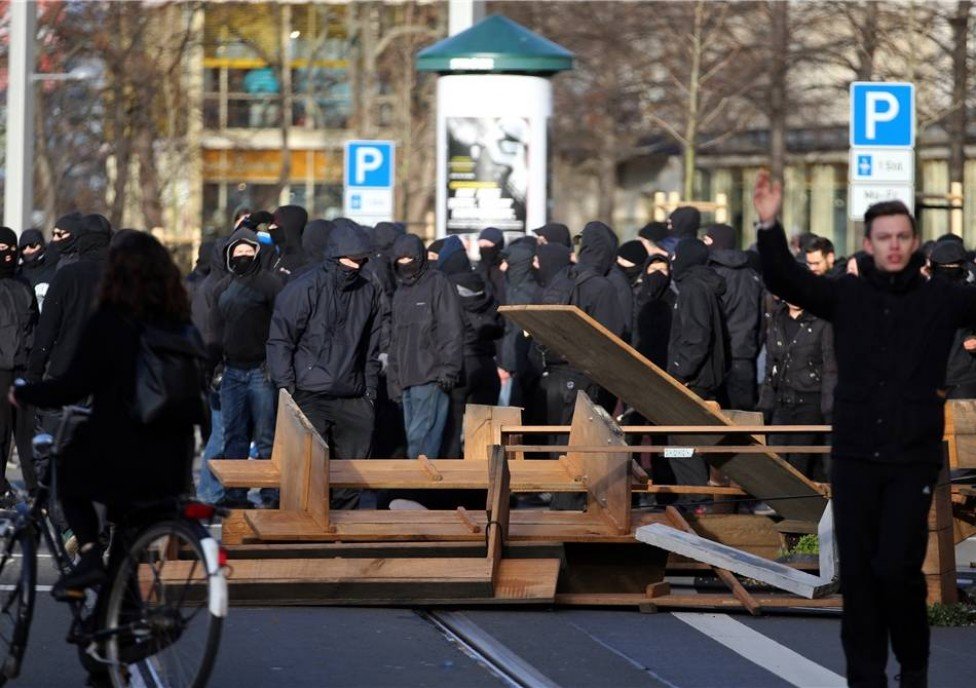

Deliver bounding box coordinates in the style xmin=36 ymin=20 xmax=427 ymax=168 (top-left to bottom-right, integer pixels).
xmin=293 ymin=390 xmax=373 ymax=509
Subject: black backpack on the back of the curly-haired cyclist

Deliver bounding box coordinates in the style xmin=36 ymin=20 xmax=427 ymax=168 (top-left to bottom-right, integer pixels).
xmin=130 ymin=324 xmax=209 ymax=425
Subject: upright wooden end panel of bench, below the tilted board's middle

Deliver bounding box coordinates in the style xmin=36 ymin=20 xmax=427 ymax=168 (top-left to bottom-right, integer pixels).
xmin=567 ymin=392 xmax=631 ymax=533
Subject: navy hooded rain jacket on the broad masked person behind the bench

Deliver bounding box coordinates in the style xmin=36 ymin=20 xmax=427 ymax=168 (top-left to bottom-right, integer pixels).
xmin=267 ymin=224 xmax=383 ymax=398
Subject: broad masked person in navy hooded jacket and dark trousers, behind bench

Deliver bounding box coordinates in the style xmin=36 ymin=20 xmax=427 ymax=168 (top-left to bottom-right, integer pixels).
xmin=267 ymin=224 xmax=383 ymax=509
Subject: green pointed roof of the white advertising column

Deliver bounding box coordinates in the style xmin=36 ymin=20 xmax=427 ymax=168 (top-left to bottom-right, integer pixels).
xmin=417 ymin=14 xmax=573 ymax=74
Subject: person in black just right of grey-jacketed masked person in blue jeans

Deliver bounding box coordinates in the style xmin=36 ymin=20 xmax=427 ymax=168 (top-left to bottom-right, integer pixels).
xmin=437 ymin=236 xmax=505 ymax=459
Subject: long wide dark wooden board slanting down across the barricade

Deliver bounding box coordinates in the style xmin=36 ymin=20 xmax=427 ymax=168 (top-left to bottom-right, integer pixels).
xmin=499 ymin=306 xmax=826 ymax=522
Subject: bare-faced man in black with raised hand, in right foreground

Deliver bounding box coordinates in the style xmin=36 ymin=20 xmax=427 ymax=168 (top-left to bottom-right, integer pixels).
xmin=754 ymin=173 xmax=976 ymax=686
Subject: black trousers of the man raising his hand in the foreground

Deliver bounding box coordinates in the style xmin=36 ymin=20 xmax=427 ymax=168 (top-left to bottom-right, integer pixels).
xmin=831 ymin=457 xmax=939 ymax=687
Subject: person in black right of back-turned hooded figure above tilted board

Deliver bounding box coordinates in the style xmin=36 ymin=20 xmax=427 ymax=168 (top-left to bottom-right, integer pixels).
xmin=705 ymin=225 xmax=763 ymax=411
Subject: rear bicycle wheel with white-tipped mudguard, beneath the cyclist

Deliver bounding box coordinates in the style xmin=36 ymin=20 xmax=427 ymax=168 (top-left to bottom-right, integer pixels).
xmin=104 ymin=521 xmax=227 ymax=688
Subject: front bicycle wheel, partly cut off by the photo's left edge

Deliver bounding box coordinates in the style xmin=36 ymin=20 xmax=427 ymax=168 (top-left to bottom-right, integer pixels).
xmin=0 ymin=525 xmax=37 ymax=686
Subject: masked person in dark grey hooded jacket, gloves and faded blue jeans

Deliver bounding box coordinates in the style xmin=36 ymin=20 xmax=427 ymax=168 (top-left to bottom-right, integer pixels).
xmin=387 ymin=234 xmax=464 ymax=459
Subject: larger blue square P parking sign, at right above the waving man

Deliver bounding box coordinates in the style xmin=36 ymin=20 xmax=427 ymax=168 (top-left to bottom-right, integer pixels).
xmin=851 ymin=81 xmax=915 ymax=148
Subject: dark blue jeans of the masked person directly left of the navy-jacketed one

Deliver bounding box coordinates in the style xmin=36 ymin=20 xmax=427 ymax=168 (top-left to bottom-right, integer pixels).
xmin=220 ymin=366 xmax=278 ymax=501
